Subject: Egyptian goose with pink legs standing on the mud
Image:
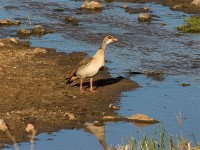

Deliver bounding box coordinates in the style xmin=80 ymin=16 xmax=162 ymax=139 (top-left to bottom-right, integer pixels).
xmin=67 ymin=35 xmax=117 ymax=92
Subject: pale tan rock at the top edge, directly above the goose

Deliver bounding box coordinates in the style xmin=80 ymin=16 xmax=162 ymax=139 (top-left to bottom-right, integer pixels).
xmin=81 ymin=0 xmax=103 ymax=10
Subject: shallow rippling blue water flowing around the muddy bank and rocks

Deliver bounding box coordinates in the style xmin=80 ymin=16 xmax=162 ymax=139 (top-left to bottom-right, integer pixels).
xmin=0 ymin=0 xmax=200 ymax=149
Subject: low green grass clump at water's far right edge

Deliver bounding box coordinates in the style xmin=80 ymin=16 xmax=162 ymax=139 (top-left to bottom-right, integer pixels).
xmin=177 ymin=16 xmax=200 ymax=33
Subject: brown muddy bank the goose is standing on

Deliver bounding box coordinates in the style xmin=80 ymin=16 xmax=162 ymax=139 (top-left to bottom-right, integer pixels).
xmin=0 ymin=39 xmax=138 ymax=147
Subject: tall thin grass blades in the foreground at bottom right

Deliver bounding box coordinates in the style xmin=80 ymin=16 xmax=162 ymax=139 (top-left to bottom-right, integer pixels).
xmin=111 ymin=125 xmax=200 ymax=150
